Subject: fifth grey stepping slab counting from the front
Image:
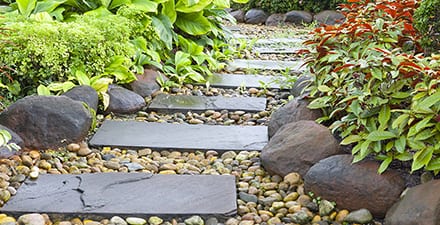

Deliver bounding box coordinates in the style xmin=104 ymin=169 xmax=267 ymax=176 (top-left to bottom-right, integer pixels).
xmin=227 ymin=59 xmax=305 ymax=73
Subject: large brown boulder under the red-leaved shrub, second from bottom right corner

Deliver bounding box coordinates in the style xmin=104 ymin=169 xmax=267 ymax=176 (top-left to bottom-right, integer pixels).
xmin=304 ymin=154 xmax=405 ymax=218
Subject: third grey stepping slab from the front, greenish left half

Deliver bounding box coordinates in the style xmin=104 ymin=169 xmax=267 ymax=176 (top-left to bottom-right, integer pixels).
xmin=148 ymin=94 xmax=266 ymax=113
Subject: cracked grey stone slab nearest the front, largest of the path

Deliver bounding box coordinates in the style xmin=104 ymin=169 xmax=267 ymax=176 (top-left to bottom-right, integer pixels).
xmin=1 ymin=173 xmax=237 ymax=218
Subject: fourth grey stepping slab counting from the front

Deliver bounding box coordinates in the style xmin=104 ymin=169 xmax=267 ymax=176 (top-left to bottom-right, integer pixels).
xmin=205 ymin=73 xmax=286 ymax=89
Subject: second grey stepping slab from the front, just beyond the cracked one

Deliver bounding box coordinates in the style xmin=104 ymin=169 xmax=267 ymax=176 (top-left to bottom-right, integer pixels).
xmin=89 ymin=120 xmax=268 ymax=151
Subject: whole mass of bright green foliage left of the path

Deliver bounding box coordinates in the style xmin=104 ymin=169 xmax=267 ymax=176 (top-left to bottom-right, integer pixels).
xmin=0 ymin=0 xmax=246 ymax=106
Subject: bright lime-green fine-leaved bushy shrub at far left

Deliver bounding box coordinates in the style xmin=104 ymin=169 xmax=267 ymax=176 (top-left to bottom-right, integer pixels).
xmin=0 ymin=15 xmax=134 ymax=98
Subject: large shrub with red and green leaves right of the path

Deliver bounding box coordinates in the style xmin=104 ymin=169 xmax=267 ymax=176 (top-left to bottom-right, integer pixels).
xmin=304 ymin=0 xmax=440 ymax=173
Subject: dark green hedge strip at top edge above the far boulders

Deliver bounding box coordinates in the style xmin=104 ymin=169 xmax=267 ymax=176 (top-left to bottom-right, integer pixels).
xmin=234 ymin=0 xmax=346 ymax=13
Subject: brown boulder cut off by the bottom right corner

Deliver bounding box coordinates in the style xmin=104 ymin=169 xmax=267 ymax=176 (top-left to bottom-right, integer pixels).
xmin=385 ymin=180 xmax=440 ymax=225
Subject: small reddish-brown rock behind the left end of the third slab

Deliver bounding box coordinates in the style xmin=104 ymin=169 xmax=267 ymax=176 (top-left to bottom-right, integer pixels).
xmin=130 ymin=69 xmax=165 ymax=97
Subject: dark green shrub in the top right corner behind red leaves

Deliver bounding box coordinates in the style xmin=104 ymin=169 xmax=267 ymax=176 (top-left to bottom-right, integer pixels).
xmin=414 ymin=0 xmax=440 ymax=53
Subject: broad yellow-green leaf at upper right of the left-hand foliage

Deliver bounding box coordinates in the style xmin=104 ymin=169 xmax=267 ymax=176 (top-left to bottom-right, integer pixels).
xmin=175 ymin=12 xmax=211 ymax=36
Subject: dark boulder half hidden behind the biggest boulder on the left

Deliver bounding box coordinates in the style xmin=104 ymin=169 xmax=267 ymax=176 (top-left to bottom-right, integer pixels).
xmin=63 ymin=85 xmax=99 ymax=112
